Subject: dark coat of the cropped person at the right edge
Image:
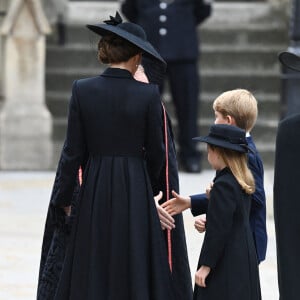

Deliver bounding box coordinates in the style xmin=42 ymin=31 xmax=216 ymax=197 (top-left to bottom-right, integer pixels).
xmin=274 ymin=114 xmax=300 ymax=300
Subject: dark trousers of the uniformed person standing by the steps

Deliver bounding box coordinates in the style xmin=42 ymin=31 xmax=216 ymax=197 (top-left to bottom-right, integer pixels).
xmin=161 ymin=60 xmax=200 ymax=160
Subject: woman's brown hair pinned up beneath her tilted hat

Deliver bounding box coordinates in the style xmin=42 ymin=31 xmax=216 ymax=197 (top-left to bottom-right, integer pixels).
xmin=98 ymin=34 xmax=142 ymax=64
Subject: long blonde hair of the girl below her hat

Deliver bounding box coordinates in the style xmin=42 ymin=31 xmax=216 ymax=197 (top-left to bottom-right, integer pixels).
xmin=209 ymin=145 xmax=255 ymax=194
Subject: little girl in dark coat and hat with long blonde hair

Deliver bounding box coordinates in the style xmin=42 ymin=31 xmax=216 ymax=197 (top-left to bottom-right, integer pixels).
xmin=171 ymin=124 xmax=261 ymax=300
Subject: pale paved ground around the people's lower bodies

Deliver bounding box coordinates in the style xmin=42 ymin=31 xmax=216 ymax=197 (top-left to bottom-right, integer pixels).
xmin=0 ymin=170 xmax=278 ymax=300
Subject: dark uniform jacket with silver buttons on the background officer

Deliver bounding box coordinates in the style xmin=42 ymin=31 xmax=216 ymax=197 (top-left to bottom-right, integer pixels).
xmin=121 ymin=0 xmax=210 ymax=61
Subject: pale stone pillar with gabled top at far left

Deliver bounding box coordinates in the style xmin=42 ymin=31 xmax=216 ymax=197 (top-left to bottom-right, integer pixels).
xmin=0 ymin=0 xmax=52 ymax=170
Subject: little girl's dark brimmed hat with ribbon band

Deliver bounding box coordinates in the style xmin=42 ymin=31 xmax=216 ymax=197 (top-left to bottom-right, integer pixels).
xmin=193 ymin=124 xmax=249 ymax=153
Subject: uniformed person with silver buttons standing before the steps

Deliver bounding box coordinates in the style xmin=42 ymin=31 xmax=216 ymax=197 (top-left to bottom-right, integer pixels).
xmin=121 ymin=0 xmax=211 ymax=172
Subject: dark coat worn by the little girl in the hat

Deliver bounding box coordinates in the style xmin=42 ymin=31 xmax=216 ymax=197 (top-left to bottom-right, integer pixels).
xmin=194 ymin=168 xmax=261 ymax=300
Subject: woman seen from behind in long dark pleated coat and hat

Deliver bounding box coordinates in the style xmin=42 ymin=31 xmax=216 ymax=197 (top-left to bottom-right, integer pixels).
xmin=38 ymin=14 xmax=192 ymax=300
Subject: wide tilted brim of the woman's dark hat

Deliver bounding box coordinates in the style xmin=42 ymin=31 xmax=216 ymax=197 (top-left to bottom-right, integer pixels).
xmin=86 ymin=24 xmax=166 ymax=65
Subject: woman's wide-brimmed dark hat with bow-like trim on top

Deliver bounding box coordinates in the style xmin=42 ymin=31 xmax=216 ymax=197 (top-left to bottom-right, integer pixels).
xmin=86 ymin=12 xmax=166 ymax=65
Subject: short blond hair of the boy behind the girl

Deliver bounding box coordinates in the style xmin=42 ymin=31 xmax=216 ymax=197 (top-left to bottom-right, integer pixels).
xmin=213 ymin=89 xmax=257 ymax=132
